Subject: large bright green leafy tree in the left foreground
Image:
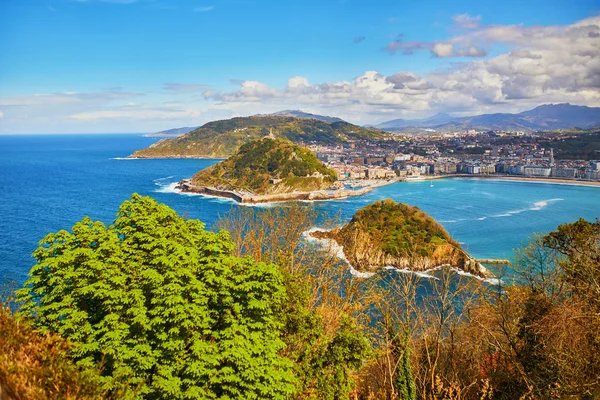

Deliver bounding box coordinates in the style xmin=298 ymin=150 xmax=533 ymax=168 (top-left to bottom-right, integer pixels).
xmin=18 ymin=194 xmax=294 ymax=399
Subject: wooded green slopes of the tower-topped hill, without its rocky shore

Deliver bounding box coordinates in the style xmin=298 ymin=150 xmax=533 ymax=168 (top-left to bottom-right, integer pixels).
xmin=192 ymin=138 xmax=336 ymax=194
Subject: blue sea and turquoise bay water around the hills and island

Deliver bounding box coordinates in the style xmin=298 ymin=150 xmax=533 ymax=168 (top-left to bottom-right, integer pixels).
xmin=0 ymin=134 xmax=600 ymax=284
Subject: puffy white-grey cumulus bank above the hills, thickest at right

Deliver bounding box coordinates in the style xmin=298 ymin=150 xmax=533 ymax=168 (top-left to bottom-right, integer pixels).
xmin=207 ymin=17 xmax=600 ymax=120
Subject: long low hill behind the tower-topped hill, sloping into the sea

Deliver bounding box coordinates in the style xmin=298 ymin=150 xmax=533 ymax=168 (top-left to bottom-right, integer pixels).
xmin=131 ymin=116 xmax=384 ymax=158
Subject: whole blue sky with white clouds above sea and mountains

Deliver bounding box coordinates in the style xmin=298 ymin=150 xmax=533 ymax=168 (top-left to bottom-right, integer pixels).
xmin=0 ymin=0 xmax=600 ymax=134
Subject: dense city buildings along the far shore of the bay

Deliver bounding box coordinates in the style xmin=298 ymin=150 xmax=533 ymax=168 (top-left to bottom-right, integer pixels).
xmin=309 ymin=131 xmax=600 ymax=181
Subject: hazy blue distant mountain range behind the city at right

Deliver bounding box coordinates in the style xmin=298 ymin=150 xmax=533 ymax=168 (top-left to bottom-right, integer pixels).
xmin=375 ymin=104 xmax=600 ymax=131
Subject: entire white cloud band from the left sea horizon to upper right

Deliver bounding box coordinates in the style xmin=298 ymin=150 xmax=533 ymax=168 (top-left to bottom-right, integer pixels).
xmin=5 ymin=16 xmax=600 ymax=132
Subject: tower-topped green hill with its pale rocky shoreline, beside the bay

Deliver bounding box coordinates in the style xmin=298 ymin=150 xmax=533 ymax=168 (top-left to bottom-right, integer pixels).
xmin=178 ymin=136 xmax=390 ymax=203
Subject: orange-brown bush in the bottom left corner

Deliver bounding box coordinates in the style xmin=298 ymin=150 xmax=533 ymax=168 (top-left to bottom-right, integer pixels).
xmin=0 ymin=305 xmax=119 ymax=400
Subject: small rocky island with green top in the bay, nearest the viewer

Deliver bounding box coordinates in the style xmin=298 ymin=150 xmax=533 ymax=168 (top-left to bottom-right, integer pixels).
xmin=311 ymin=199 xmax=492 ymax=278
